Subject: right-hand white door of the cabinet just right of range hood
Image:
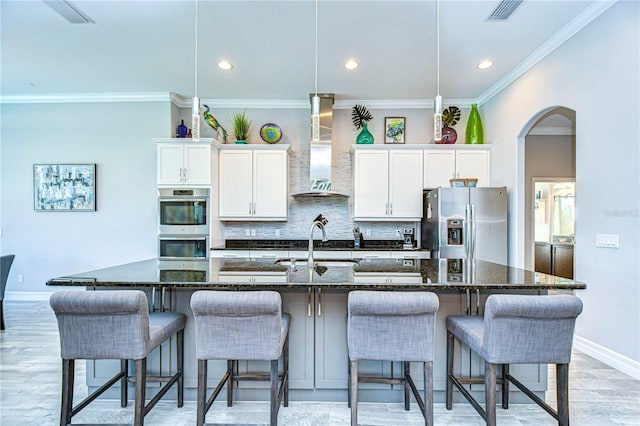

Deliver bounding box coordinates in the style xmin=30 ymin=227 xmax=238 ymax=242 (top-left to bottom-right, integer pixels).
xmin=389 ymin=150 xmax=423 ymax=220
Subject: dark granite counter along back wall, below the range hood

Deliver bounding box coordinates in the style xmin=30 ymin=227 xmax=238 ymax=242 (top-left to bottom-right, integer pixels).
xmin=211 ymin=240 xmax=421 ymax=251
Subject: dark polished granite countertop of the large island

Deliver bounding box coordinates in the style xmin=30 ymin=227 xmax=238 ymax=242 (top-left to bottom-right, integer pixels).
xmin=47 ymin=259 xmax=586 ymax=290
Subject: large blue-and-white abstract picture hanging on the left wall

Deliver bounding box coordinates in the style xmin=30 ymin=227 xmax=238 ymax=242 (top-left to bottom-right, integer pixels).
xmin=33 ymin=164 xmax=96 ymax=212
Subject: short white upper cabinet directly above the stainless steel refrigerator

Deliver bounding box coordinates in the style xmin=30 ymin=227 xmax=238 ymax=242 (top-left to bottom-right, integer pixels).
xmin=423 ymin=145 xmax=491 ymax=189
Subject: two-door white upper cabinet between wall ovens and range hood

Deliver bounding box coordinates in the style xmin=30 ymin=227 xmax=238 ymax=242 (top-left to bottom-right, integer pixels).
xmin=218 ymin=144 xmax=289 ymax=221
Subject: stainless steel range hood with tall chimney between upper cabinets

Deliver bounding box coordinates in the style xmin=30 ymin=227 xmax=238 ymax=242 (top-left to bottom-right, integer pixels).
xmin=291 ymin=94 xmax=349 ymax=198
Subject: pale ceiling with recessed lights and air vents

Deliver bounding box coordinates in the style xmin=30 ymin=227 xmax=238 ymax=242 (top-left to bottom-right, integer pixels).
xmin=0 ymin=0 xmax=599 ymax=100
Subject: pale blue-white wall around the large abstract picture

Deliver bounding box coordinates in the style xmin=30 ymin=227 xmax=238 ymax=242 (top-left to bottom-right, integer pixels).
xmin=0 ymin=102 xmax=170 ymax=292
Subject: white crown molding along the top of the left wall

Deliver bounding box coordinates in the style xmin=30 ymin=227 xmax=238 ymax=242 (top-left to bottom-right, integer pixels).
xmin=0 ymin=92 xmax=171 ymax=104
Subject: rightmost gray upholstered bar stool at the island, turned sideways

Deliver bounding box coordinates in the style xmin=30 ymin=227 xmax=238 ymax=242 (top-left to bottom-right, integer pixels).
xmin=446 ymin=294 xmax=582 ymax=426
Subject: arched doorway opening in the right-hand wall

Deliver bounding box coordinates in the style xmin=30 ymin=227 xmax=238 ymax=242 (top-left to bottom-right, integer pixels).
xmin=517 ymin=106 xmax=576 ymax=270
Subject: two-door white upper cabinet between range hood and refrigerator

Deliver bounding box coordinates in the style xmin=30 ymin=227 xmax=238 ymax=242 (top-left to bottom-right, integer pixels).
xmin=352 ymin=145 xmax=423 ymax=221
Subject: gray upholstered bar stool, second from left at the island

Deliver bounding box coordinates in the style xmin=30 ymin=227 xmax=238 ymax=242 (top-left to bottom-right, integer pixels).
xmin=191 ymin=290 xmax=291 ymax=426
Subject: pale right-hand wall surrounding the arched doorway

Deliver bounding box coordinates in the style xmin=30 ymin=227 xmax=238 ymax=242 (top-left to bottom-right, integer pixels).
xmin=482 ymin=1 xmax=640 ymax=365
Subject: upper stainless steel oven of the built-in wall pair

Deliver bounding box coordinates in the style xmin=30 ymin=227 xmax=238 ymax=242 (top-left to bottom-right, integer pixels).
xmin=158 ymin=188 xmax=210 ymax=235
